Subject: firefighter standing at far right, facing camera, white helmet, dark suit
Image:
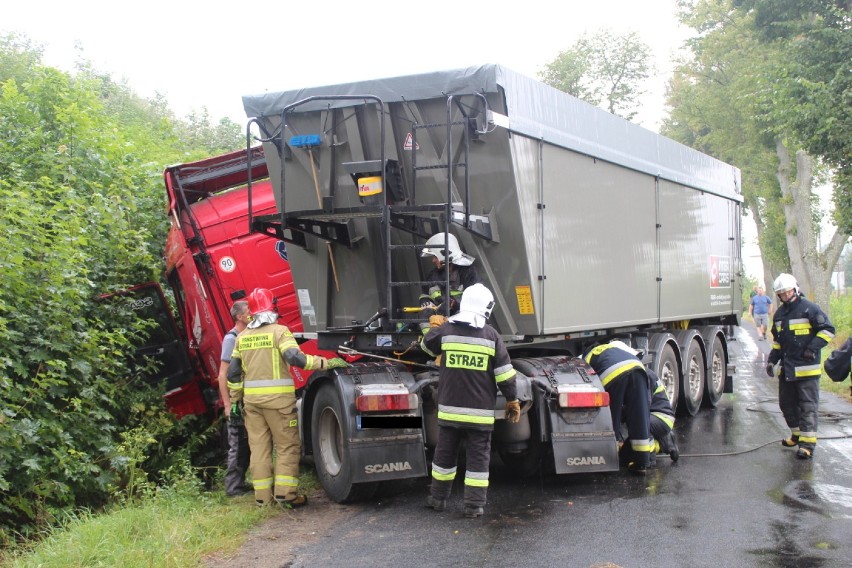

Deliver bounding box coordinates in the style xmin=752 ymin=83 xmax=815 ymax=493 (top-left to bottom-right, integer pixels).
xmin=766 ymin=273 xmax=834 ymax=460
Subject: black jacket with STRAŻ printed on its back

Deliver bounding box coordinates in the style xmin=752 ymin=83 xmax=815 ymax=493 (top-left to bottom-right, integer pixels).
xmin=421 ymin=322 xmax=517 ymax=430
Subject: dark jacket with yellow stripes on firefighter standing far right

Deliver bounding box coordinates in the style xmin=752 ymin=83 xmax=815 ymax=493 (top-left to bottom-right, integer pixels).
xmin=767 ymin=296 xmax=834 ymax=381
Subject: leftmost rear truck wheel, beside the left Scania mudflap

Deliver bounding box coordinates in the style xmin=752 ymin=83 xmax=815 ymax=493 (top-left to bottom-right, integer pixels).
xmin=311 ymin=386 xmax=377 ymax=503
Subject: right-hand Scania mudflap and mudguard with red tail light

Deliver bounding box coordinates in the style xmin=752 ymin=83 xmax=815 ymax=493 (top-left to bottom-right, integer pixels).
xmin=512 ymin=357 xmax=619 ymax=474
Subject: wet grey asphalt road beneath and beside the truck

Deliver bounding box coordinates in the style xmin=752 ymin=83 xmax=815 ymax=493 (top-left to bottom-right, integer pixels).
xmin=282 ymin=324 xmax=852 ymax=568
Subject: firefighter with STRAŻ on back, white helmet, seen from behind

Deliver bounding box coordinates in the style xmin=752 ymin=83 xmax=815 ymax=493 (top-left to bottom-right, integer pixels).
xmin=421 ymin=284 xmax=521 ymax=518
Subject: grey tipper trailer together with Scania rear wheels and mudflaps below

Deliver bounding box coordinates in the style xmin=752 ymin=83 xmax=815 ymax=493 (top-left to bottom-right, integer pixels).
xmin=243 ymin=65 xmax=742 ymax=501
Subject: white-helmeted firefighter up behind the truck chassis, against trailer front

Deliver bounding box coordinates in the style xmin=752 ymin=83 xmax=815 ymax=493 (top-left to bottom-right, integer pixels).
xmin=420 ymin=233 xmax=481 ymax=314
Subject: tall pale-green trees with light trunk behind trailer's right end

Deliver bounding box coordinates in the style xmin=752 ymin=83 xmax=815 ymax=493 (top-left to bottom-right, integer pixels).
xmin=663 ymin=0 xmax=849 ymax=305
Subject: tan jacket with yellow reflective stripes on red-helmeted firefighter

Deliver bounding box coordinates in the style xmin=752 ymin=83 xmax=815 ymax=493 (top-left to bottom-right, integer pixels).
xmin=228 ymin=324 xmax=325 ymax=408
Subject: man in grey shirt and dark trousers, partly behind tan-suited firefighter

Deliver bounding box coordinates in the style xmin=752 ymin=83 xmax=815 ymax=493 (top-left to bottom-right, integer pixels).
xmin=219 ymin=300 xmax=251 ymax=497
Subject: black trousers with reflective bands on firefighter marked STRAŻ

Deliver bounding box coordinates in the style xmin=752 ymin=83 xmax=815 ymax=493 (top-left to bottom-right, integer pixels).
xmin=430 ymin=426 xmax=491 ymax=507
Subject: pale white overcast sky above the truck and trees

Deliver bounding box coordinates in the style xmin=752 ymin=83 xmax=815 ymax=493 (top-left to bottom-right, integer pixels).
xmin=0 ymin=0 xmax=687 ymax=130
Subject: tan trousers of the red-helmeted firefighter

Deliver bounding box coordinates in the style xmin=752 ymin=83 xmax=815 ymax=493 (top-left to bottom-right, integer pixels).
xmin=244 ymin=402 xmax=301 ymax=503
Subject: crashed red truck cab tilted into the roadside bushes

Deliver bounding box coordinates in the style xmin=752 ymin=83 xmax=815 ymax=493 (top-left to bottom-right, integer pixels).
xmin=111 ymin=146 xmax=310 ymax=420
